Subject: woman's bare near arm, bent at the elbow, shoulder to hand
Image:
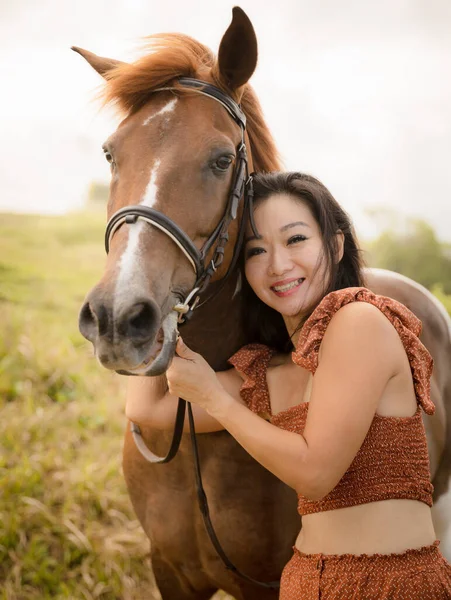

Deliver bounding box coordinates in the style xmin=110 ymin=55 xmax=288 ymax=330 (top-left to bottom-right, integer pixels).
xmin=168 ymin=302 xmax=405 ymax=500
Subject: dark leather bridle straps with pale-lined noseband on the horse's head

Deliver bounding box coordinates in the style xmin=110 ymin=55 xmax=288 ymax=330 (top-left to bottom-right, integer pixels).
xmin=105 ymin=77 xmax=252 ymax=323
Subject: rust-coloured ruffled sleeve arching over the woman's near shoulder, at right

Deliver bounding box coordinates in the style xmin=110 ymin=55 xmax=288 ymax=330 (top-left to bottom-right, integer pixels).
xmin=292 ymin=288 xmax=435 ymax=415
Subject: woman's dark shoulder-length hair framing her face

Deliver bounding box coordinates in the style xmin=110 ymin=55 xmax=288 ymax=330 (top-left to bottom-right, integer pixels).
xmin=241 ymin=172 xmax=364 ymax=352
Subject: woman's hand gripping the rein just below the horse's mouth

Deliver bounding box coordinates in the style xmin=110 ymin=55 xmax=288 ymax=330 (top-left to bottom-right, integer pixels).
xmin=166 ymin=338 xmax=225 ymax=410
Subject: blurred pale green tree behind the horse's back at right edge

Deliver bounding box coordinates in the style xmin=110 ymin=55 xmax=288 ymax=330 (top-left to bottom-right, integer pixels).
xmin=368 ymin=213 xmax=451 ymax=294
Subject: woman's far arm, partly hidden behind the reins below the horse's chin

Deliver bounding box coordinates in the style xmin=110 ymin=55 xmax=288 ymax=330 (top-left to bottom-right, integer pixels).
xmin=125 ymin=369 xmax=243 ymax=433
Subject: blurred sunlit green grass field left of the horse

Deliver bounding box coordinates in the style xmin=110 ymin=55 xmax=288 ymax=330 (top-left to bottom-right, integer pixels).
xmin=0 ymin=213 xmax=451 ymax=600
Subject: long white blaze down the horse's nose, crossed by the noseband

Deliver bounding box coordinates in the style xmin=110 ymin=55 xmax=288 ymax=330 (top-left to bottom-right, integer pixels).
xmin=114 ymin=159 xmax=160 ymax=310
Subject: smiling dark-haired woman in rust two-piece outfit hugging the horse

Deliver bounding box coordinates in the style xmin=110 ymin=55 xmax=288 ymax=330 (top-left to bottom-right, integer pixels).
xmin=126 ymin=173 xmax=451 ymax=600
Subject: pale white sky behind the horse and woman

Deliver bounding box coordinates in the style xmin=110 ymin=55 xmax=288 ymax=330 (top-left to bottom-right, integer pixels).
xmin=0 ymin=0 xmax=451 ymax=241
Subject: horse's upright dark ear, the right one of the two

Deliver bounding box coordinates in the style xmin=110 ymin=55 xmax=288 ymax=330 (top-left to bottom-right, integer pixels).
xmin=214 ymin=6 xmax=258 ymax=91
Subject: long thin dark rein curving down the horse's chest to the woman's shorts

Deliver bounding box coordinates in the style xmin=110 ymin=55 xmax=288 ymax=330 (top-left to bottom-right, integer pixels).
xmin=183 ymin=401 xmax=280 ymax=590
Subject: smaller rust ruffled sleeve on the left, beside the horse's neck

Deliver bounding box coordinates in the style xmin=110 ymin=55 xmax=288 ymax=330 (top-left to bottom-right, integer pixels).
xmin=228 ymin=344 xmax=274 ymax=419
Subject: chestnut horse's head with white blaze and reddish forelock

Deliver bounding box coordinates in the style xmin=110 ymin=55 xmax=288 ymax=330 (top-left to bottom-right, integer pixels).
xmin=74 ymin=8 xmax=278 ymax=375
